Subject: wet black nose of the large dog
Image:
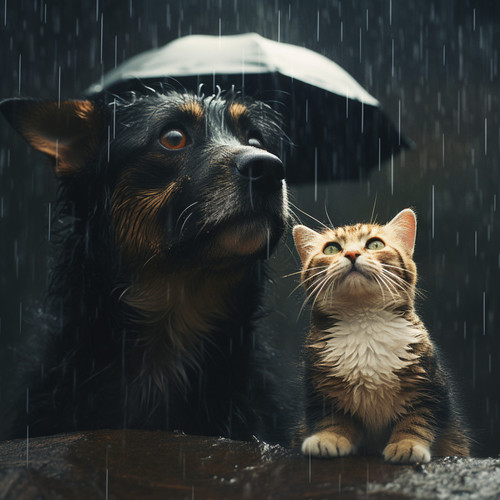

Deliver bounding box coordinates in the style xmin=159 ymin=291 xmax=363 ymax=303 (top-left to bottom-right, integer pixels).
xmin=234 ymin=148 xmax=285 ymax=190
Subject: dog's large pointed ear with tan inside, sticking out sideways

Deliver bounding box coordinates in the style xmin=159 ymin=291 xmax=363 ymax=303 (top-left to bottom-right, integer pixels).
xmin=0 ymin=99 xmax=104 ymax=176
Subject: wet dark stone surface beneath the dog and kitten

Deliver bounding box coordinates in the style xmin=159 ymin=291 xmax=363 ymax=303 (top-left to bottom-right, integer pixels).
xmin=0 ymin=430 xmax=500 ymax=500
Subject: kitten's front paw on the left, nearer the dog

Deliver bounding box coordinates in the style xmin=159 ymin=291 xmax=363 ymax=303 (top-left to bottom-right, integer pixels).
xmin=302 ymin=415 xmax=359 ymax=457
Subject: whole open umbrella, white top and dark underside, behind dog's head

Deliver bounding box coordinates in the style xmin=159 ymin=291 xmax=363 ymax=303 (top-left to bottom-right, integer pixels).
xmin=87 ymin=33 xmax=410 ymax=183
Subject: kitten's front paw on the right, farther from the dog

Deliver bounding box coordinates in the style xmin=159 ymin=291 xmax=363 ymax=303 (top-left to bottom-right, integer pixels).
xmin=383 ymin=414 xmax=434 ymax=463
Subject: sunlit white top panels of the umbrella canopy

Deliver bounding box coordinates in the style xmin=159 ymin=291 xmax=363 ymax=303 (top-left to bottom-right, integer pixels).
xmin=89 ymin=33 xmax=379 ymax=106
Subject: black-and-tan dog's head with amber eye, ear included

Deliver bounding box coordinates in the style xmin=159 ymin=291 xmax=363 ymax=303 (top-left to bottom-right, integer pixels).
xmin=0 ymin=91 xmax=287 ymax=269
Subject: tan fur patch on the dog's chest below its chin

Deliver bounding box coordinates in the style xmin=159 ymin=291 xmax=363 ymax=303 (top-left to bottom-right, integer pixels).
xmin=123 ymin=266 xmax=245 ymax=390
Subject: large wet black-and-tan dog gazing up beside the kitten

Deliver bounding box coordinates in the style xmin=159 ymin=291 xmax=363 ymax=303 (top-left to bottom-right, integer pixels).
xmin=0 ymin=91 xmax=287 ymax=442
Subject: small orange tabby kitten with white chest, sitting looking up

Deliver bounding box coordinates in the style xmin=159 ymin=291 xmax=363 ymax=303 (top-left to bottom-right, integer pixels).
xmin=293 ymin=209 xmax=470 ymax=463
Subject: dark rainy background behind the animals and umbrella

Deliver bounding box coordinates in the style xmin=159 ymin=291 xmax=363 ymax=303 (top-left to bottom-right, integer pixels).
xmin=0 ymin=0 xmax=500 ymax=456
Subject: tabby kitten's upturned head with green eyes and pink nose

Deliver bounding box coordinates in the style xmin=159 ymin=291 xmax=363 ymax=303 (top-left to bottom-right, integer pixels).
xmin=293 ymin=209 xmax=417 ymax=309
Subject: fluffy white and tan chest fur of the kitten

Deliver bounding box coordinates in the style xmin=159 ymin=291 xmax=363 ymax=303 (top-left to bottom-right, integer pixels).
xmin=321 ymin=311 xmax=422 ymax=428
